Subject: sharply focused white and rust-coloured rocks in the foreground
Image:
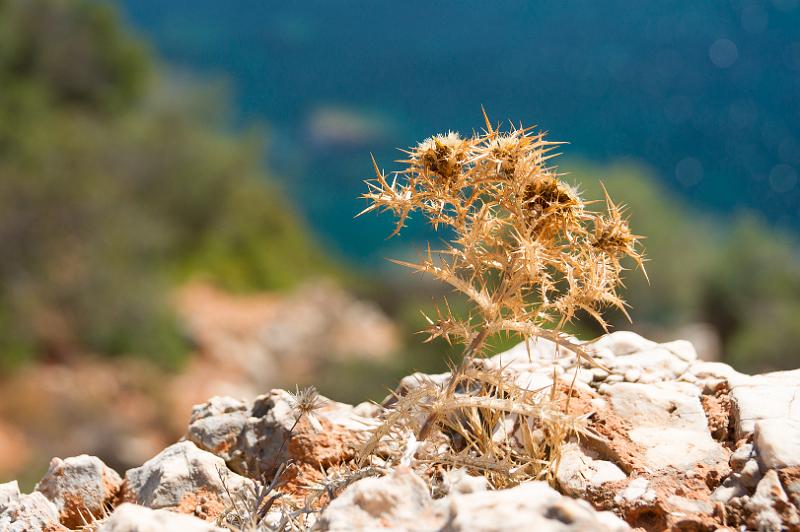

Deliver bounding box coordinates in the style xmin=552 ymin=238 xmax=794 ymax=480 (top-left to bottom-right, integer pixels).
xmin=0 ymin=332 xmax=800 ymax=531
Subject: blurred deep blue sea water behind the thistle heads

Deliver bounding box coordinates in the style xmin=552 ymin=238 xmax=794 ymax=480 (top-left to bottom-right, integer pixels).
xmin=122 ymin=0 xmax=800 ymax=258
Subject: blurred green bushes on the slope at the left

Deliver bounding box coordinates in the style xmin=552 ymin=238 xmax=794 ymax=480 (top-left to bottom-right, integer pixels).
xmin=0 ymin=0 xmax=333 ymax=370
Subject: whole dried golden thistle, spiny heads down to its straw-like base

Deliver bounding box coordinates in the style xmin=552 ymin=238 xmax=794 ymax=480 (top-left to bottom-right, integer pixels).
xmin=360 ymin=112 xmax=644 ymax=482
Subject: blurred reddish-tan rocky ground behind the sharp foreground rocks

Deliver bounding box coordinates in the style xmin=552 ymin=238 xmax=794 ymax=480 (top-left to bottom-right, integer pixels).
xmin=0 ymin=281 xmax=400 ymax=486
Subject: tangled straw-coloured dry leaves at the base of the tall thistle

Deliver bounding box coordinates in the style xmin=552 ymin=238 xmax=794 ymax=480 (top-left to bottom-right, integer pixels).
xmin=359 ymin=364 xmax=600 ymax=488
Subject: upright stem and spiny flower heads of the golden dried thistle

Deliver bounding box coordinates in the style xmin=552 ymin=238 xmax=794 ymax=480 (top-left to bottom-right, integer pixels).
xmin=360 ymin=112 xmax=644 ymax=439
